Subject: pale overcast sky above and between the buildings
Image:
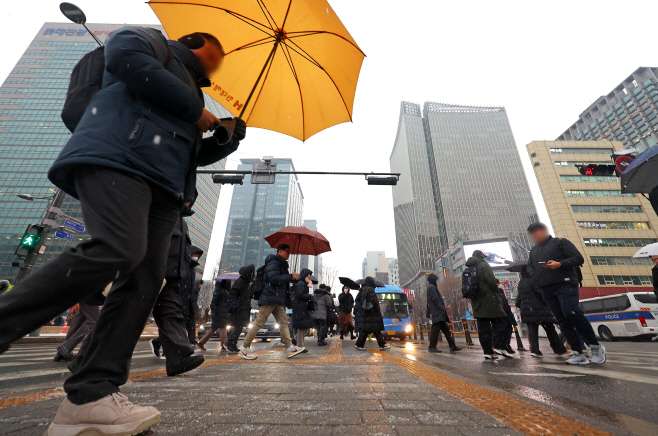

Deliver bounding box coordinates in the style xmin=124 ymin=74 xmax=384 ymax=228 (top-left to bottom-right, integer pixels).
xmin=0 ymin=0 xmax=658 ymax=277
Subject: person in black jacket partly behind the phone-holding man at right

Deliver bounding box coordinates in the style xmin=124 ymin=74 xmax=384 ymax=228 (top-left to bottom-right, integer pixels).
xmin=516 ymin=267 xmax=567 ymax=357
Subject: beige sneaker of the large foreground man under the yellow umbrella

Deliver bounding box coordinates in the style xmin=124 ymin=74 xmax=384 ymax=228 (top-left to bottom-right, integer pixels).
xmin=44 ymin=392 xmax=160 ymax=436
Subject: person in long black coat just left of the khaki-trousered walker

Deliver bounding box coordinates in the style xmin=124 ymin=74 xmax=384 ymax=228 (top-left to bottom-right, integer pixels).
xmin=226 ymin=264 xmax=256 ymax=354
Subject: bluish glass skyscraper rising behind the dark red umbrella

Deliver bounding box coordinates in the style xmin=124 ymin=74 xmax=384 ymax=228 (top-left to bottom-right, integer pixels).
xmin=219 ymin=159 xmax=304 ymax=272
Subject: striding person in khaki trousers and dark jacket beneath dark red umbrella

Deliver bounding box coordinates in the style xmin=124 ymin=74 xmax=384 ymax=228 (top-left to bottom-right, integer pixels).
xmin=240 ymin=244 xmax=304 ymax=360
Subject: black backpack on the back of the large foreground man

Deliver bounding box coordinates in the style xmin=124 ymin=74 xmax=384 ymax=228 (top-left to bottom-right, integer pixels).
xmin=61 ymin=46 xmax=105 ymax=133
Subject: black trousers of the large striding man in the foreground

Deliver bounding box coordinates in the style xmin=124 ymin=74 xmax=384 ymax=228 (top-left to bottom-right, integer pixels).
xmin=0 ymin=167 xmax=180 ymax=404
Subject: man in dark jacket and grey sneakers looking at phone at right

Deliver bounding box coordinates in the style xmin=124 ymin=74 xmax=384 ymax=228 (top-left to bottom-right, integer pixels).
xmin=527 ymin=222 xmax=605 ymax=365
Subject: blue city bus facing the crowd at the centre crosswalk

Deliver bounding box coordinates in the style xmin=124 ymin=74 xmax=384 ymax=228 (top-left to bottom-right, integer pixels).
xmin=375 ymin=285 xmax=413 ymax=340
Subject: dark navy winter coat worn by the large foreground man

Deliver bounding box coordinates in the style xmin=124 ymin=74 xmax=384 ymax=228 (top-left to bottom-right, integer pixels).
xmin=48 ymin=26 xmax=238 ymax=206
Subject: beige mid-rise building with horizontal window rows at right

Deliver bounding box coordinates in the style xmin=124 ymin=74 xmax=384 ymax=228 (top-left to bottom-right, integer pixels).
xmin=527 ymin=141 xmax=658 ymax=298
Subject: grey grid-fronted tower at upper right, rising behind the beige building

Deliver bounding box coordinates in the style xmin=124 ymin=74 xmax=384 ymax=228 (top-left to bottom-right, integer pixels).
xmin=557 ymin=67 xmax=658 ymax=151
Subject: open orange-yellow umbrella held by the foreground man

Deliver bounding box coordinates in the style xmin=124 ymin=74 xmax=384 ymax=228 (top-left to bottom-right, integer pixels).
xmin=149 ymin=0 xmax=365 ymax=141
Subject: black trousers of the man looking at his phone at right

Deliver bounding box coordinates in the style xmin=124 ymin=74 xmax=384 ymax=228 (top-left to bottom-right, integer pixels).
xmin=542 ymin=284 xmax=599 ymax=353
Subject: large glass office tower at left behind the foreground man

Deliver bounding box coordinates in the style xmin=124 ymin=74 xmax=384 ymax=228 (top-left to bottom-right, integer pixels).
xmin=0 ymin=23 xmax=230 ymax=279
